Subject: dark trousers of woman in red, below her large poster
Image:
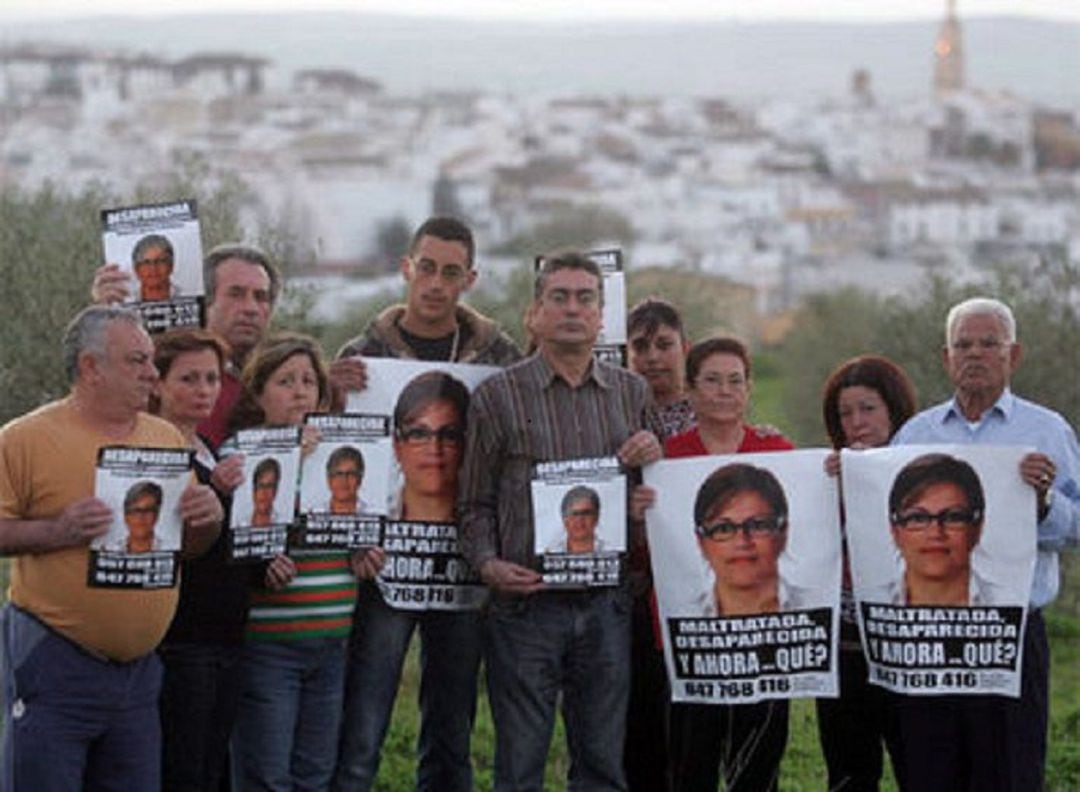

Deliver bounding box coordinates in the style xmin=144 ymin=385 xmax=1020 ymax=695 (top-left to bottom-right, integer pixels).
xmin=671 ymin=700 xmax=787 ymax=792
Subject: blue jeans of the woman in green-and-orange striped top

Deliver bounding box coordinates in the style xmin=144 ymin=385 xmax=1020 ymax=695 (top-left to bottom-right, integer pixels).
xmin=232 ymin=637 xmax=346 ymax=792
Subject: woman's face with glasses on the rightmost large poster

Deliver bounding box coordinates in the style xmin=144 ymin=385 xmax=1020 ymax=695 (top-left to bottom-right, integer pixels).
xmin=892 ymin=482 xmax=981 ymax=593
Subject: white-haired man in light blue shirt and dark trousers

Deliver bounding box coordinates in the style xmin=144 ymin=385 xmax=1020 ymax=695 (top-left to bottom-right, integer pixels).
xmin=892 ymin=297 xmax=1080 ymax=790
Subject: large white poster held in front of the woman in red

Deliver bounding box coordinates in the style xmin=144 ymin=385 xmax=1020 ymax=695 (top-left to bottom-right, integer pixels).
xmin=644 ymin=451 xmax=841 ymax=703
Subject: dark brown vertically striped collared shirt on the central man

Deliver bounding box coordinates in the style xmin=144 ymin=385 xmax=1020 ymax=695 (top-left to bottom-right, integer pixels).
xmin=458 ymin=354 xmax=649 ymax=569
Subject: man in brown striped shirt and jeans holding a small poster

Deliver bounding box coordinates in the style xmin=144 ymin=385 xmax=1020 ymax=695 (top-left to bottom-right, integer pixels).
xmin=460 ymin=252 xmax=660 ymax=790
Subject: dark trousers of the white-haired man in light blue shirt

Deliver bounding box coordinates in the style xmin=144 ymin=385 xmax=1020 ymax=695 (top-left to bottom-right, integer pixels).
xmin=895 ymin=610 xmax=1050 ymax=792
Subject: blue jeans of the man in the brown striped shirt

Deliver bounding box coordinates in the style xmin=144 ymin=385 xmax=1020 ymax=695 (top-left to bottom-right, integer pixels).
xmin=484 ymin=589 xmax=630 ymax=792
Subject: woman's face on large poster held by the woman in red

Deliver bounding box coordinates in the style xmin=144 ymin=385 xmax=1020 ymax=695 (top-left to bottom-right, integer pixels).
xmin=698 ymin=489 xmax=786 ymax=590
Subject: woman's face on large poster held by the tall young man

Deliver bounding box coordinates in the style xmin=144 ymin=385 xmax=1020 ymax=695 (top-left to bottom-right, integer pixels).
xmin=394 ymin=401 xmax=464 ymax=498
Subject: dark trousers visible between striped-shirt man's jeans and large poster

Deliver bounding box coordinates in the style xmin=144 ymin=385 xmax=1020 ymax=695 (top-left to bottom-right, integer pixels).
xmin=623 ymin=591 xmax=671 ymax=792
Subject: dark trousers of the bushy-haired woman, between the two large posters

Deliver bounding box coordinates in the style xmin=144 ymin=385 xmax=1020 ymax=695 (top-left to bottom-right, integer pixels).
xmin=816 ymin=649 xmax=896 ymax=792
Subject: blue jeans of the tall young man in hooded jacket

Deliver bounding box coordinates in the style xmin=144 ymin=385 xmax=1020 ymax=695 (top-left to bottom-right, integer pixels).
xmin=334 ymin=585 xmax=481 ymax=792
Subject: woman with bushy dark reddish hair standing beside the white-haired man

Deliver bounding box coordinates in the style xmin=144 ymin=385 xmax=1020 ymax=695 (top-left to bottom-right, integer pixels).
xmin=818 ymin=354 xmax=916 ymax=789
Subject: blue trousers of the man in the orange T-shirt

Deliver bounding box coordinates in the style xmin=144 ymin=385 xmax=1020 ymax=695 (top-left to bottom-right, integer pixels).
xmin=0 ymin=605 xmax=161 ymax=792
